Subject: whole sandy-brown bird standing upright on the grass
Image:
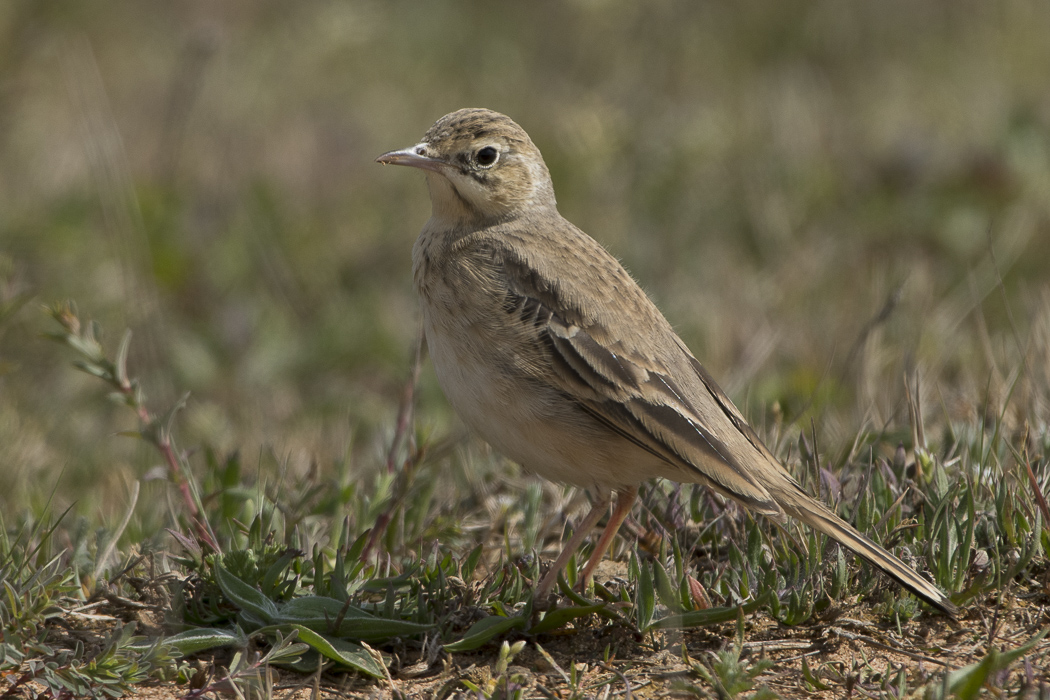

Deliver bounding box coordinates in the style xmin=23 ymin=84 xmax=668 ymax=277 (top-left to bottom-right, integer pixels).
xmin=376 ymin=108 xmax=958 ymax=616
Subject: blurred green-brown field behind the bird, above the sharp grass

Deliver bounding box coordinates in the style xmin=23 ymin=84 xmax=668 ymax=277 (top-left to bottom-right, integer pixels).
xmin=0 ymin=0 xmax=1050 ymax=520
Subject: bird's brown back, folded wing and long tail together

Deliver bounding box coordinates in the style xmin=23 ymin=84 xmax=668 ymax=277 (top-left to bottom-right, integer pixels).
xmin=496 ymin=229 xmax=957 ymax=615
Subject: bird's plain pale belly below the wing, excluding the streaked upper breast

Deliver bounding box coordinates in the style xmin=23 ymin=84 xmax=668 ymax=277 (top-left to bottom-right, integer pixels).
xmin=424 ymin=310 xmax=667 ymax=489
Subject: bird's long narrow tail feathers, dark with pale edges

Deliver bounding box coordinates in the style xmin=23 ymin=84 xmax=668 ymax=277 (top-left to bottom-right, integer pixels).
xmin=780 ymin=485 xmax=959 ymax=617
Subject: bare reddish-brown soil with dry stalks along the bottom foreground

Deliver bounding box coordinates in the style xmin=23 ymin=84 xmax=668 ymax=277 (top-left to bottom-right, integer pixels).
xmin=55 ymin=582 xmax=1050 ymax=700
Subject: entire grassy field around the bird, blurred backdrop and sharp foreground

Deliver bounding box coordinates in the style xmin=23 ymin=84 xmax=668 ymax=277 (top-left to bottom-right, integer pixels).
xmin=0 ymin=0 xmax=1050 ymax=697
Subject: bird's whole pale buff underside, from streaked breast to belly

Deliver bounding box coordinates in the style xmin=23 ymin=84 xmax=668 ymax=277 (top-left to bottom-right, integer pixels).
xmin=414 ymin=232 xmax=653 ymax=488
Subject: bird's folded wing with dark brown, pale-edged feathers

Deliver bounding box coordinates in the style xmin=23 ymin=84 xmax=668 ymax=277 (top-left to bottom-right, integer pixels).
xmin=503 ymin=243 xmax=782 ymax=515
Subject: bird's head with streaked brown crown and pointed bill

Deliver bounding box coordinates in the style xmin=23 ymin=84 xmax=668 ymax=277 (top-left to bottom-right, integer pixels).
xmin=376 ymin=109 xmax=555 ymax=224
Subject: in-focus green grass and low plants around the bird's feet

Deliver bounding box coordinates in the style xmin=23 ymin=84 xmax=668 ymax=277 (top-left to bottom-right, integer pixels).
xmin=0 ymin=298 xmax=1050 ymax=697
